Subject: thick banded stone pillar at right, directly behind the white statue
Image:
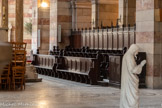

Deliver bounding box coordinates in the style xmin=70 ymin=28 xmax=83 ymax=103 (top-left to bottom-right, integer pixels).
xmin=136 ymin=0 xmax=162 ymax=88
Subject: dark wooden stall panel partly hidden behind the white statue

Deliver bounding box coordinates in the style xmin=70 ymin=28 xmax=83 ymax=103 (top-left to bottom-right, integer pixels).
xmin=109 ymin=52 xmax=146 ymax=88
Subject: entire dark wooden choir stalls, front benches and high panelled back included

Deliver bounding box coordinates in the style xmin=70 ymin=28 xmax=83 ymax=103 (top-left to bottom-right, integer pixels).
xmin=33 ymin=26 xmax=146 ymax=87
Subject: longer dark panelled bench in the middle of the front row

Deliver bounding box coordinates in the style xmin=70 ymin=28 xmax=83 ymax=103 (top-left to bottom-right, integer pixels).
xmin=56 ymin=56 xmax=99 ymax=84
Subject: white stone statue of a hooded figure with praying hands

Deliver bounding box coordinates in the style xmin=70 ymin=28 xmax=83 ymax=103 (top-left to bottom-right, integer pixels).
xmin=120 ymin=44 xmax=146 ymax=108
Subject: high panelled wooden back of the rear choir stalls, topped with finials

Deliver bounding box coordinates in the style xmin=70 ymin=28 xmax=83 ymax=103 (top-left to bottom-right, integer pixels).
xmin=72 ymin=26 xmax=136 ymax=50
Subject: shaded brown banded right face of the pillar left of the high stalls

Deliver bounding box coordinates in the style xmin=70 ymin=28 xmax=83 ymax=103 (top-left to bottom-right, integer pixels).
xmin=57 ymin=0 xmax=72 ymax=48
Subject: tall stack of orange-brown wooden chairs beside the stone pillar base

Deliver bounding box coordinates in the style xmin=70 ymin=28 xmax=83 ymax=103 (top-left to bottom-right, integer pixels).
xmin=12 ymin=50 xmax=26 ymax=90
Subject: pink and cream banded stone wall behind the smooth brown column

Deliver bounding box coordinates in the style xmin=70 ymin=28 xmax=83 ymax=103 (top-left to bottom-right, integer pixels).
xmin=8 ymin=0 xmax=33 ymax=55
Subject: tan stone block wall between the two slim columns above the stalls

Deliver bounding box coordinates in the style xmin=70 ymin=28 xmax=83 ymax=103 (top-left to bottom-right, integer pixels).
xmin=98 ymin=4 xmax=118 ymax=26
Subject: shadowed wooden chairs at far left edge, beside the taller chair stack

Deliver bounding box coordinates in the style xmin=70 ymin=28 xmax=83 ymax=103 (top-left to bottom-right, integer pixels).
xmin=0 ymin=64 xmax=11 ymax=90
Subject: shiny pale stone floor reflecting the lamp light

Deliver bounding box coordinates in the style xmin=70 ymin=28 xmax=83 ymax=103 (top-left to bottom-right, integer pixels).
xmin=0 ymin=75 xmax=162 ymax=108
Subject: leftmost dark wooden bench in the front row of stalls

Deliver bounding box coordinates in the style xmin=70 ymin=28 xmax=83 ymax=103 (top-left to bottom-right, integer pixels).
xmin=33 ymin=54 xmax=56 ymax=76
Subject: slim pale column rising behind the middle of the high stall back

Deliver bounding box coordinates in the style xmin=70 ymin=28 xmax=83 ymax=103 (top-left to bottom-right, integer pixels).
xmin=91 ymin=0 xmax=99 ymax=28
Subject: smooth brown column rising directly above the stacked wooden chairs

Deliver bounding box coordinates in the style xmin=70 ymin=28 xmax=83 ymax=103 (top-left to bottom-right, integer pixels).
xmin=15 ymin=0 xmax=24 ymax=42
